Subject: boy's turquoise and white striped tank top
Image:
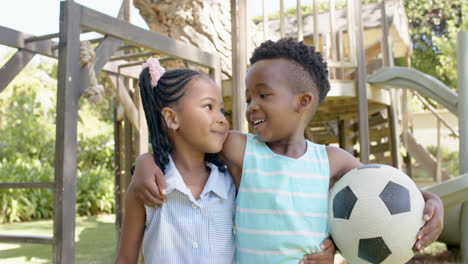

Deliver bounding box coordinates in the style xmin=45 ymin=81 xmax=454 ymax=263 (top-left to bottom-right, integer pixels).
xmin=235 ymin=134 xmax=330 ymax=264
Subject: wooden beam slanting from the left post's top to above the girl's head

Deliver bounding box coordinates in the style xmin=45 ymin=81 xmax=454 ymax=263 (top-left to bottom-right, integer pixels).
xmin=80 ymin=6 xmax=219 ymax=68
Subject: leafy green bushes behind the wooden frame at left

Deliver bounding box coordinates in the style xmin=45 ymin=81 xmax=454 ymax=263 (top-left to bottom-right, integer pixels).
xmin=0 ymin=55 xmax=114 ymax=223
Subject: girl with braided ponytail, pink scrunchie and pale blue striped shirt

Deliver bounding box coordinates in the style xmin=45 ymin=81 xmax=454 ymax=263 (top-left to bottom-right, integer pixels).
xmin=115 ymin=58 xmax=236 ymax=264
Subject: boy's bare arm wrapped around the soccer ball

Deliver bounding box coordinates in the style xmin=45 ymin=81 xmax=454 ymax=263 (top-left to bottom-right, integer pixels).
xmin=327 ymin=146 xmax=444 ymax=252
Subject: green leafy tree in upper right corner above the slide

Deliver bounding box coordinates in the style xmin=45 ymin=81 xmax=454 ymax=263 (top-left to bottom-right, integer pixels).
xmin=404 ymin=0 xmax=468 ymax=90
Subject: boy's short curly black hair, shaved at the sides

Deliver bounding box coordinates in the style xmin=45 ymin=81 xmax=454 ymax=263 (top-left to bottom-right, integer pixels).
xmin=250 ymin=38 xmax=330 ymax=105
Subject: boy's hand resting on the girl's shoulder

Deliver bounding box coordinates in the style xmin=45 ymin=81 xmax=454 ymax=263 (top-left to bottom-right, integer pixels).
xmin=131 ymin=153 xmax=167 ymax=207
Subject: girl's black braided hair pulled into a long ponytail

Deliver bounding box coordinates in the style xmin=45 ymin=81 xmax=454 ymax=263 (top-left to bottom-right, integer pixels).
xmin=138 ymin=68 xmax=225 ymax=172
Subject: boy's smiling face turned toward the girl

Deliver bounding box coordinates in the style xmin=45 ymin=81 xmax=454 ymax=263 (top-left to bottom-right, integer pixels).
xmin=245 ymin=59 xmax=299 ymax=142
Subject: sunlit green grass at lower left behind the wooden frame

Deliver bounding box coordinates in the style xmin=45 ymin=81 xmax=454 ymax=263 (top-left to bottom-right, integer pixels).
xmin=0 ymin=215 xmax=116 ymax=264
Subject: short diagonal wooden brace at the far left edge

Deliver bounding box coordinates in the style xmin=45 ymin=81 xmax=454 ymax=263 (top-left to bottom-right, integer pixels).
xmin=0 ymin=50 xmax=35 ymax=93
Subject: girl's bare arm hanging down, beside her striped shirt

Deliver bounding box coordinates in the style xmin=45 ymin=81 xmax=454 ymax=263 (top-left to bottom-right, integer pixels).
xmin=115 ymin=186 xmax=146 ymax=264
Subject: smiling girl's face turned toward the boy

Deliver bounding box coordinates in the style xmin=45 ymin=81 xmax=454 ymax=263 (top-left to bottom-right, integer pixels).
xmin=174 ymin=76 xmax=229 ymax=153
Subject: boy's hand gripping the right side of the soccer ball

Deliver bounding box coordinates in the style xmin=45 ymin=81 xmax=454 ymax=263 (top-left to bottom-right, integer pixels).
xmin=414 ymin=192 xmax=444 ymax=253
